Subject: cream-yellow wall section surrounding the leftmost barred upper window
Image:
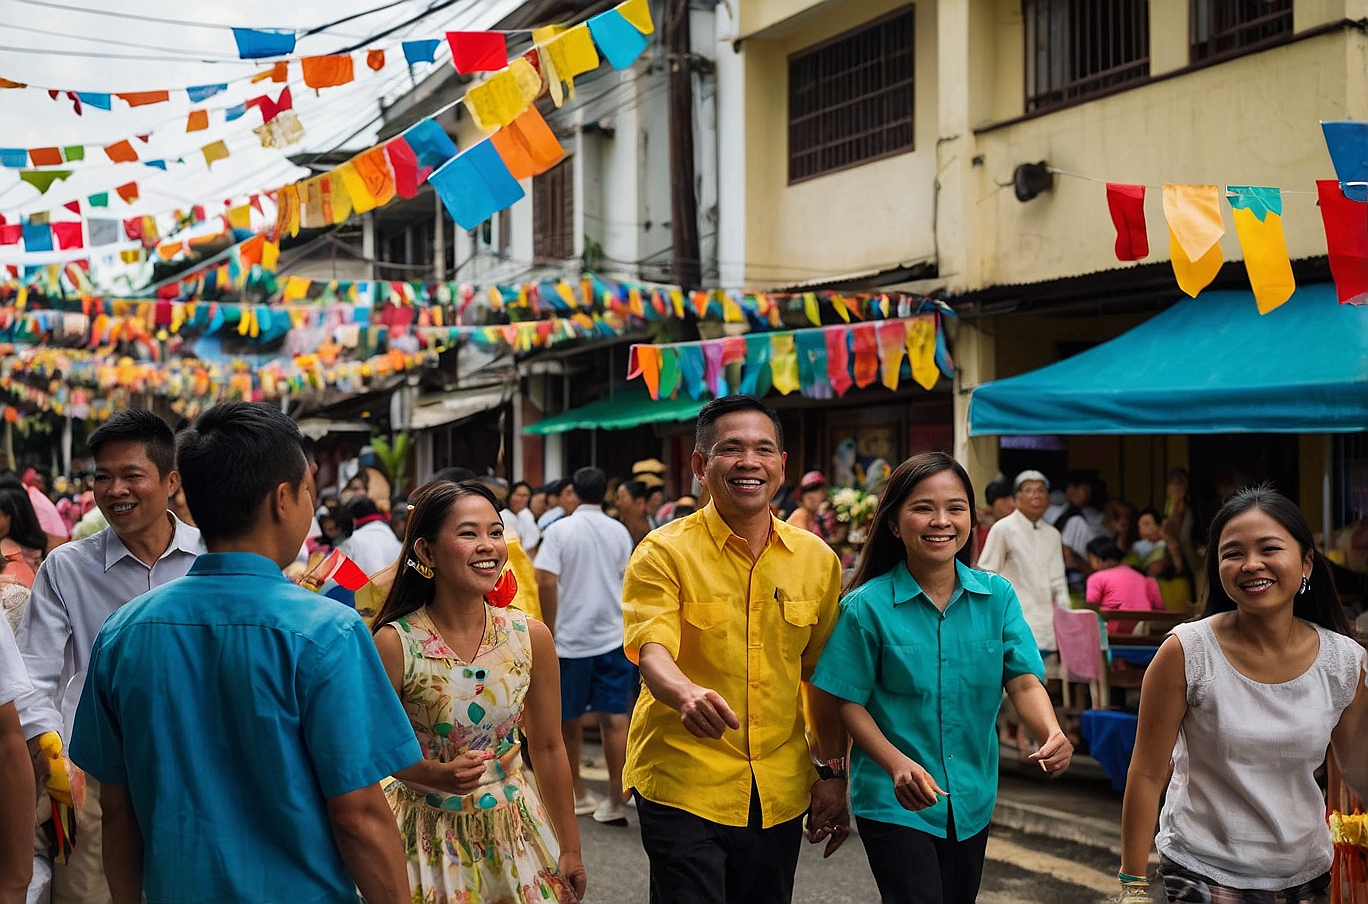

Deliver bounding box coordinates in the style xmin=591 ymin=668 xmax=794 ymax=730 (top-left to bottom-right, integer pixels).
xmin=741 ymin=0 xmax=937 ymax=286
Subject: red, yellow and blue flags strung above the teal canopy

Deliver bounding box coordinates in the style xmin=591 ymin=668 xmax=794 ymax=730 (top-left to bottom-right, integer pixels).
xmin=1107 ymin=122 xmax=1368 ymax=315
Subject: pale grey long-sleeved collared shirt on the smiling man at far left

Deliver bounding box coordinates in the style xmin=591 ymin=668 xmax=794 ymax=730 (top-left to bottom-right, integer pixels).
xmin=18 ymin=511 xmax=204 ymax=739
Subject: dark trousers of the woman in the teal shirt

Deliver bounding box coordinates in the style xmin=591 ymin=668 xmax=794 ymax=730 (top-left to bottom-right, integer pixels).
xmin=855 ymin=814 xmax=988 ymax=904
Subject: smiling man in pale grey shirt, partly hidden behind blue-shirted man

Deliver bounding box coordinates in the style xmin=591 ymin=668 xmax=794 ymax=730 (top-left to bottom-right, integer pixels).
xmin=18 ymin=409 xmax=204 ymax=904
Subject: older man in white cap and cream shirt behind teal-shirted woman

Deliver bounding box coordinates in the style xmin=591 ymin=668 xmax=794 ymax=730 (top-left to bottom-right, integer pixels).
xmin=978 ymin=470 xmax=1070 ymax=655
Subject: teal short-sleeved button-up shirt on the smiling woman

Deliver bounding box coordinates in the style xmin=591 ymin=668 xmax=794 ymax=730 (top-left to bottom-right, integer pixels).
xmin=813 ymin=562 xmax=1045 ymax=841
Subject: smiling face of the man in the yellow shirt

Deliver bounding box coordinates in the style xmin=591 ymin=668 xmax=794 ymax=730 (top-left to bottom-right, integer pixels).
xmin=694 ymin=412 xmax=788 ymax=520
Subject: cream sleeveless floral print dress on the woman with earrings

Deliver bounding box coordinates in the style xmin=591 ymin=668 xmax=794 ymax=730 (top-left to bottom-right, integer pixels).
xmin=384 ymin=606 xmax=576 ymax=904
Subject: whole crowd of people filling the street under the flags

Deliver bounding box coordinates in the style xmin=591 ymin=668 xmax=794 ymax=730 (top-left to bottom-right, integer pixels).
xmin=0 ymin=395 xmax=1368 ymax=904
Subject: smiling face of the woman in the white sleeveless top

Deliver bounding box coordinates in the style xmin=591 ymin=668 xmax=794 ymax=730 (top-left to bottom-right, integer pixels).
xmin=1216 ymin=509 xmax=1312 ymax=613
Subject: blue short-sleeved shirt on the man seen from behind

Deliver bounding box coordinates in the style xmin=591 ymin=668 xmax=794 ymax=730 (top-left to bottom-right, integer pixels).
xmin=71 ymin=553 xmax=423 ymax=904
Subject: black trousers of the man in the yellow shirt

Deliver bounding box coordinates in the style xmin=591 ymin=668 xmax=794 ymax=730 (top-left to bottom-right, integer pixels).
xmin=636 ymin=784 xmax=803 ymax=904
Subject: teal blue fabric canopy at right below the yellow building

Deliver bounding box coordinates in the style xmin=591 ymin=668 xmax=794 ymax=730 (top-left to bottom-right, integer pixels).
xmin=969 ymin=283 xmax=1368 ymax=436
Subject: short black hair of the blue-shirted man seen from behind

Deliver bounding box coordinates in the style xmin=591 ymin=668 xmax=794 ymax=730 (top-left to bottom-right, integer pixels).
xmin=176 ymin=402 xmax=308 ymax=542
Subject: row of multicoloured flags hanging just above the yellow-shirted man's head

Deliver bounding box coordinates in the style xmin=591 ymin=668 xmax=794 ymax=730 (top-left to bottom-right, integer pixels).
xmin=627 ymin=313 xmax=955 ymax=399
